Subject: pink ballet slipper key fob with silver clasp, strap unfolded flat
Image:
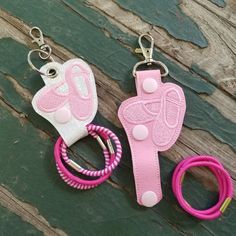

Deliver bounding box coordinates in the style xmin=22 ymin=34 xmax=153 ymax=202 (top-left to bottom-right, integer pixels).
xmin=118 ymin=34 xmax=186 ymax=207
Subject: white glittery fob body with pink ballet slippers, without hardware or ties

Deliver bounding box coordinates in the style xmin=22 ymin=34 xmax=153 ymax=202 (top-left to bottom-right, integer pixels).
xmin=32 ymin=59 xmax=98 ymax=146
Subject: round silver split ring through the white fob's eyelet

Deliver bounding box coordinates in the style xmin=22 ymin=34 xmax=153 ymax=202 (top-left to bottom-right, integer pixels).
xmin=27 ymin=49 xmax=58 ymax=78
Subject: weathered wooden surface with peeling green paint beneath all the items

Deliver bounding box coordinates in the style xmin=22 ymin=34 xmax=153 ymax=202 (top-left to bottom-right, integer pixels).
xmin=0 ymin=0 xmax=236 ymax=235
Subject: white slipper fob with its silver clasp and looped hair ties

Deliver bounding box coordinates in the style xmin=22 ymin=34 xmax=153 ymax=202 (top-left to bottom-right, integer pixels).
xmin=28 ymin=27 xmax=122 ymax=189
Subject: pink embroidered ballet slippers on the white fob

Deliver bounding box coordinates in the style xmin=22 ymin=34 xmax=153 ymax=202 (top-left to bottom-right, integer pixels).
xmin=37 ymin=63 xmax=92 ymax=120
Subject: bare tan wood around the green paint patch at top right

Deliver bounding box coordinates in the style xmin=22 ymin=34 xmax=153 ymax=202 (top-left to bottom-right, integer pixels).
xmin=87 ymin=0 xmax=235 ymax=95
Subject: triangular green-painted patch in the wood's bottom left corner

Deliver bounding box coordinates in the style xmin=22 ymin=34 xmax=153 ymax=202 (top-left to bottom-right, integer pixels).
xmin=0 ymin=206 xmax=43 ymax=236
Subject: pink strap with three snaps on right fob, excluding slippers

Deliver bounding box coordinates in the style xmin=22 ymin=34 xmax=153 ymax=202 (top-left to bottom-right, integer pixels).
xmin=130 ymin=70 xmax=162 ymax=207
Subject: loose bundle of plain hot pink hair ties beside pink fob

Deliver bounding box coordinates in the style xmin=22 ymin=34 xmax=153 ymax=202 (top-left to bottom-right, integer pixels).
xmin=172 ymin=156 xmax=233 ymax=220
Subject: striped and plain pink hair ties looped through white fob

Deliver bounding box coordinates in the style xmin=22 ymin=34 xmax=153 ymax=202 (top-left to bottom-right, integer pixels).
xmin=54 ymin=124 xmax=122 ymax=189
